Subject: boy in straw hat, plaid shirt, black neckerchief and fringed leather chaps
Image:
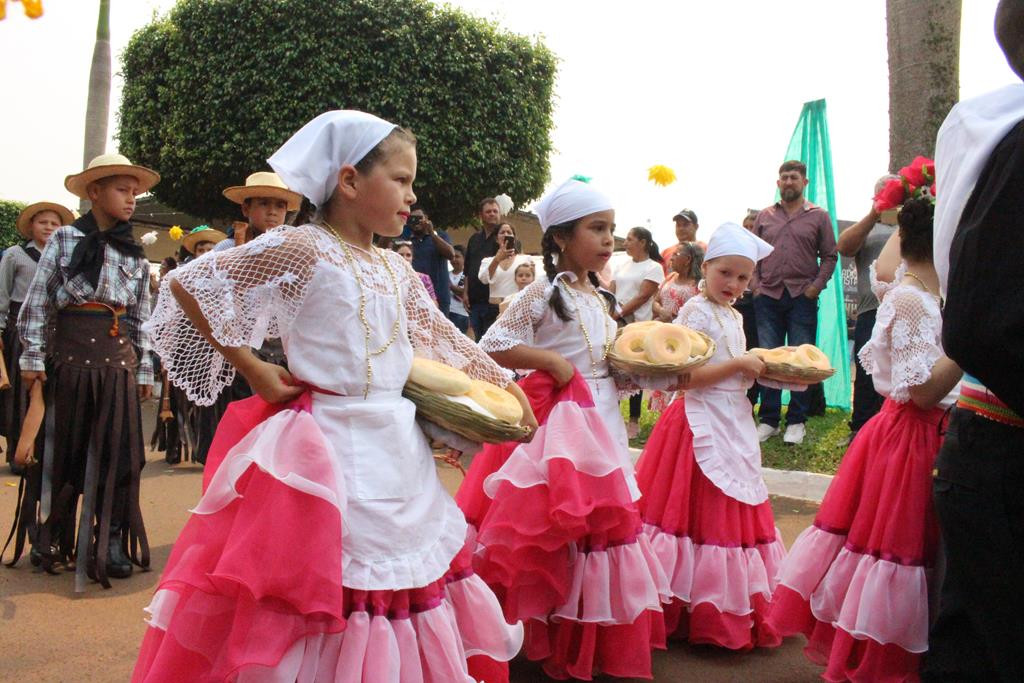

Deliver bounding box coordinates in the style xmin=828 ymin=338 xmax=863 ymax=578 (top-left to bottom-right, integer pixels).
xmin=17 ymin=155 xmax=160 ymax=592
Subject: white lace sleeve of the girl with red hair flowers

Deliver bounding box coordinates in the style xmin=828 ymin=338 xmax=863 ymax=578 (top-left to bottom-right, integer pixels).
xmin=889 ymin=288 xmax=942 ymax=402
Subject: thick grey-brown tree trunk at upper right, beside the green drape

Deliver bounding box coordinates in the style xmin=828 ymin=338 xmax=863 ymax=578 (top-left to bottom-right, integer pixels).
xmin=886 ymin=0 xmax=961 ymax=173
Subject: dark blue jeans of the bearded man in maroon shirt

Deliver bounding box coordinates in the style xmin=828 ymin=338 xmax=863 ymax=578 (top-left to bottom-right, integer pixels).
xmin=754 ymin=290 xmax=818 ymax=427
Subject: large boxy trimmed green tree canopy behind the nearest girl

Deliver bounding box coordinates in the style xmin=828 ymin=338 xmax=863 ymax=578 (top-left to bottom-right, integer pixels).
xmin=119 ymin=0 xmax=556 ymax=225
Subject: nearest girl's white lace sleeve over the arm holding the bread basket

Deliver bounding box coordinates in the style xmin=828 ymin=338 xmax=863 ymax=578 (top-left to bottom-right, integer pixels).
xmin=397 ymin=252 xmax=513 ymax=386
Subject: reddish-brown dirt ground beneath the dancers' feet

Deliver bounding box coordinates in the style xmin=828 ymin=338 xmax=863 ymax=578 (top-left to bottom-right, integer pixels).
xmin=0 ymin=403 xmax=818 ymax=683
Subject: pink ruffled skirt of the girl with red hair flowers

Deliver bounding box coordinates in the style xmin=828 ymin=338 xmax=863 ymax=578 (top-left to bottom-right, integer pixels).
xmin=768 ymin=399 xmax=943 ymax=682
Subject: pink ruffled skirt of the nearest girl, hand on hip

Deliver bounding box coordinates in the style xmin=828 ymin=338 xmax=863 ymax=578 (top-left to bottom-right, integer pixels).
xmin=132 ymin=398 xmax=521 ymax=683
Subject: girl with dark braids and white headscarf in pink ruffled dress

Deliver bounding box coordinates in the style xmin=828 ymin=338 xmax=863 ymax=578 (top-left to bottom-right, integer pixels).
xmin=456 ymin=180 xmax=675 ymax=680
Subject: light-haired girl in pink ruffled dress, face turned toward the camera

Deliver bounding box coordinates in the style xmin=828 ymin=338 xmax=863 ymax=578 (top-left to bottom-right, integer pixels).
xmin=637 ymin=223 xmax=785 ymax=650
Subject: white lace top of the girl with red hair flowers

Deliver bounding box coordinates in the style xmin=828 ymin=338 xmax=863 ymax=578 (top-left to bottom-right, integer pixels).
xmin=858 ymin=263 xmax=959 ymax=409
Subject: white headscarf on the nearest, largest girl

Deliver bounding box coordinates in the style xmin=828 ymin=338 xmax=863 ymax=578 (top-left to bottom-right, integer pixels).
xmin=267 ymin=110 xmax=397 ymax=207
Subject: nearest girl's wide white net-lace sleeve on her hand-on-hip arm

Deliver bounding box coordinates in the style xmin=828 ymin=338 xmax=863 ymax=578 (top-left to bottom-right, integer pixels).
xmin=144 ymin=225 xmax=323 ymax=405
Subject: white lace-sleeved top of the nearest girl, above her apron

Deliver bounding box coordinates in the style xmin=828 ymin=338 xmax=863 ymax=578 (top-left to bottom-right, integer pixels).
xmin=145 ymin=224 xmax=510 ymax=405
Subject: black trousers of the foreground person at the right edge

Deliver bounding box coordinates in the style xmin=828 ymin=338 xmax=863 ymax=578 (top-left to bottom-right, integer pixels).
xmin=922 ymin=409 xmax=1024 ymax=683
